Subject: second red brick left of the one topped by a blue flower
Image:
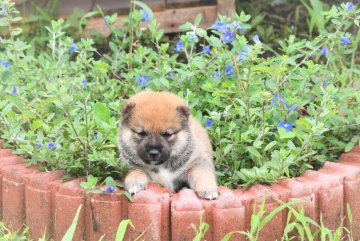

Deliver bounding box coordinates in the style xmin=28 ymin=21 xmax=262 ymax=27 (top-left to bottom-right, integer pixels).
xmin=25 ymin=171 xmax=64 ymax=240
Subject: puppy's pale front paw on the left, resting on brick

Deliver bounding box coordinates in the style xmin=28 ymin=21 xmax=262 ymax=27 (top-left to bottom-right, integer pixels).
xmin=125 ymin=170 xmax=149 ymax=194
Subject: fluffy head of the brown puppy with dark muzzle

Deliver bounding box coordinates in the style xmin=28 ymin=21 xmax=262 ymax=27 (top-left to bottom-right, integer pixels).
xmin=119 ymin=92 xmax=189 ymax=165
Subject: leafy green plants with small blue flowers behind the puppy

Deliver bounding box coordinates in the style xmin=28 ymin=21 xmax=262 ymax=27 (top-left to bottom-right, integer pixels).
xmin=0 ymin=0 xmax=360 ymax=187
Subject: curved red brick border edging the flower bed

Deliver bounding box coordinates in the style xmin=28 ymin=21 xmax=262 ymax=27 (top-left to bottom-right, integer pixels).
xmin=0 ymin=140 xmax=360 ymax=241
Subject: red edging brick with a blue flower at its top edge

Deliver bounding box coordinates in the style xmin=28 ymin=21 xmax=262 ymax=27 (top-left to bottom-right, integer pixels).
xmin=85 ymin=186 xmax=125 ymax=241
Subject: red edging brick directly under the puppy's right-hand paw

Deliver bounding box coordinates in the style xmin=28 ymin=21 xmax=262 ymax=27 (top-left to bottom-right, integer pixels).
xmin=171 ymin=189 xmax=205 ymax=241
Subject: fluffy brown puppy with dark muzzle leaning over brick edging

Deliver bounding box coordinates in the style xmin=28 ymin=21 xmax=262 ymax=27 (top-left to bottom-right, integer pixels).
xmin=118 ymin=92 xmax=218 ymax=199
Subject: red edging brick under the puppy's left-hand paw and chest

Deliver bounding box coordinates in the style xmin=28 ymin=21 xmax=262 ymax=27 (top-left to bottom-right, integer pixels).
xmin=126 ymin=184 xmax=170 ymax=241
